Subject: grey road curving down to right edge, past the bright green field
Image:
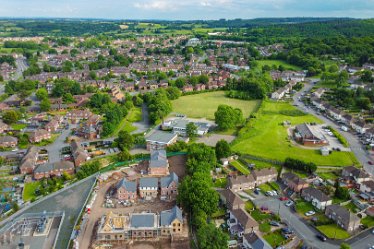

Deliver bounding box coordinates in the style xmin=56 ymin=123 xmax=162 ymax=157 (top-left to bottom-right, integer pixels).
xmin=293 ymin=84 xmax=374 ymax=175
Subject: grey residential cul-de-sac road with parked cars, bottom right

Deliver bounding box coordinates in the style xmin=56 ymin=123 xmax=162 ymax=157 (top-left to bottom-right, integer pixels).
xmin=253 ymin=195 xmax=339 ymax=249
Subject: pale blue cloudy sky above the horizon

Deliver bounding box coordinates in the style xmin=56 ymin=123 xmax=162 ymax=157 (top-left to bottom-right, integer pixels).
xmin=0 ymin=0 xmax=374 ymax=20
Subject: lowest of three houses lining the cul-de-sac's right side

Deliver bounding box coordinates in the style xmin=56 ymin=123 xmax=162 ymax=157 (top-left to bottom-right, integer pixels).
xmin=325 ymin=205 xmax=360 ymax=232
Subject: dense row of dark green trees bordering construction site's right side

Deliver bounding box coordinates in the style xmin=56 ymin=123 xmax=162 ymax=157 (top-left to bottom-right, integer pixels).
xmin=177 ymin=144 xmax=229 ymax=249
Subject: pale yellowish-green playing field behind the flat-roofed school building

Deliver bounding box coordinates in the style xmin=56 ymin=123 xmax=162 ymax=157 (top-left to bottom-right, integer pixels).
xmin=172 ymin=91 xmax=261 ymax=120
